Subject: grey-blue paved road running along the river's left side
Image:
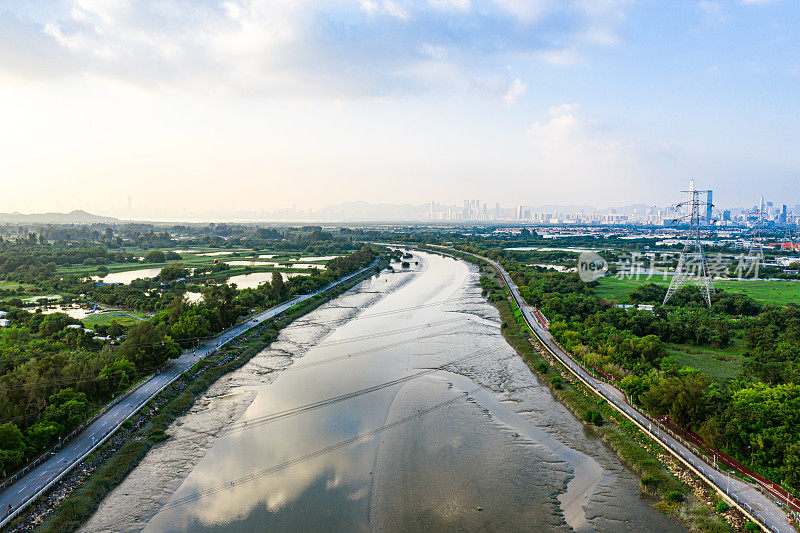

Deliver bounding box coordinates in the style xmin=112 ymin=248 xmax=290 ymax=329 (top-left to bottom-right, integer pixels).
xmin=0 ymin=260 xmax=377 ymax=527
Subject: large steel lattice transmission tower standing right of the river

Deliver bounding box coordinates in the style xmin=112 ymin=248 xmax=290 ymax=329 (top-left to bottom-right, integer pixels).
xmin=664 ymin=180 xmax=714 ymax=307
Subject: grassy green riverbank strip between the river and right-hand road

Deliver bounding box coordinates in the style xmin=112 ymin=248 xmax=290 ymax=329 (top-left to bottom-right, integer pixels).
xmin=429 ymin=249 xmax=747 ymax=531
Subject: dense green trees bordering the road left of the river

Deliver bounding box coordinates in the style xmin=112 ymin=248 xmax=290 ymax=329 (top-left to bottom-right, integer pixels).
xmin=0 ymin=245 xmax=377 ymax=474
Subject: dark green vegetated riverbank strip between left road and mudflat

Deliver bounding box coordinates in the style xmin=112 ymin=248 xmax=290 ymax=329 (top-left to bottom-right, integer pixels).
xmin=8 ymin=262 xmax=386 ymax=532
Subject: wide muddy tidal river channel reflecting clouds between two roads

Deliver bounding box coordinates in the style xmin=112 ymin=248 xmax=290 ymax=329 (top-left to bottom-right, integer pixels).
xmin=84 ymin=253 xmax=682 ymax=532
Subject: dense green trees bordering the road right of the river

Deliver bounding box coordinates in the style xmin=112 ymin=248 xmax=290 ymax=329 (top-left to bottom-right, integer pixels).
xmin=476 ymin=250 xmax=800 ymax=490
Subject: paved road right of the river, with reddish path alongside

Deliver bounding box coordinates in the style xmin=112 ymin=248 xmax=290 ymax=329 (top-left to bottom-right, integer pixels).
xmin=440 ymin=248 xmax=796 ymax=533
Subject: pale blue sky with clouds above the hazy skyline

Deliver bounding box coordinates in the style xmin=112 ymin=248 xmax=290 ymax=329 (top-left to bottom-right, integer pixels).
xmin=0 ymin=0 xmax=800 ymax=214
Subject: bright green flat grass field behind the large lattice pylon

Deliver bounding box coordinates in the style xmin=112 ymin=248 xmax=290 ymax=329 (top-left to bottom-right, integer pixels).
xmin=594 ymin=276 xmax=800 ymax=305
